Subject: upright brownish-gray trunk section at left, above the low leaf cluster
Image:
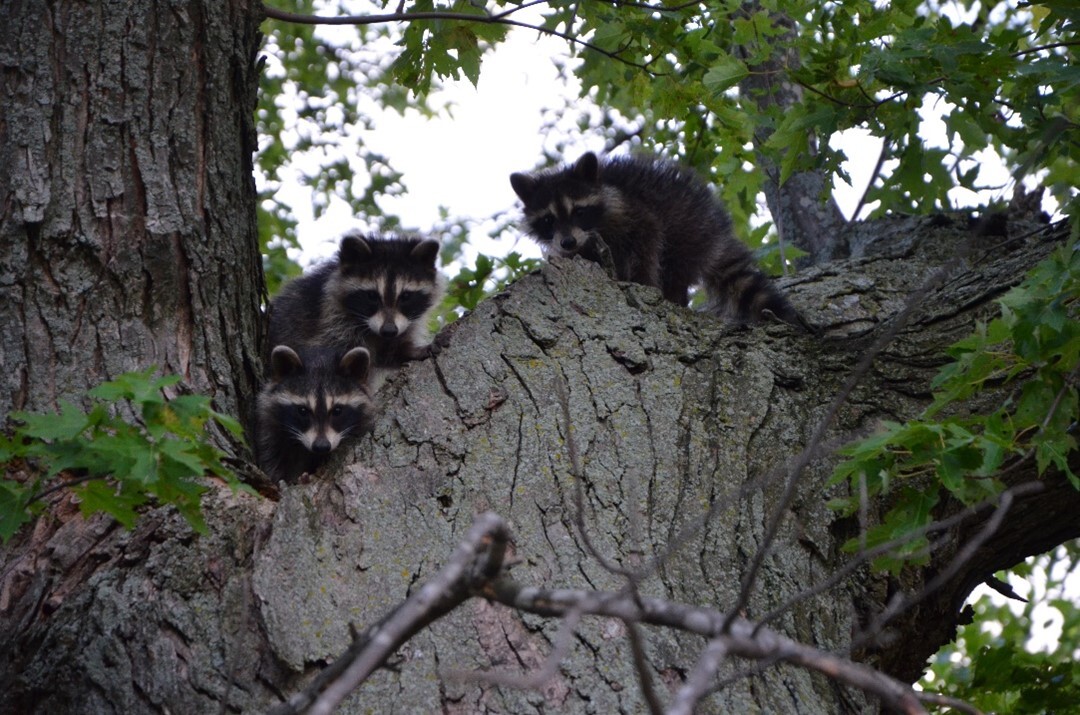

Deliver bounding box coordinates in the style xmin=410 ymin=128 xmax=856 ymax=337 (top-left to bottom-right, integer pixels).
xmin=0 ymin=0 xmax=264 ymax=421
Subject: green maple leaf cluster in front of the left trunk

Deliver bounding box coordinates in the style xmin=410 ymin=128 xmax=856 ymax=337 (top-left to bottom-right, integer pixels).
xmin=0 ymin=367 xmax=243 ymax=541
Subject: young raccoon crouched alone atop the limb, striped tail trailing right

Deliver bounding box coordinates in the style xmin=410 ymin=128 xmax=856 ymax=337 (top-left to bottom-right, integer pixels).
xmin=510 ymin=152 xmax=799 ymax=324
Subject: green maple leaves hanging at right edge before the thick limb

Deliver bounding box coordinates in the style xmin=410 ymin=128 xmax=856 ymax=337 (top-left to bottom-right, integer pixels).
xmin=829 ymin=242 xmax=1080 ymax=571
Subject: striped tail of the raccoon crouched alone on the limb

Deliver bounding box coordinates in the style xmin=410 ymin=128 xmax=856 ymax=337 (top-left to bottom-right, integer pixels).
xmin=703 ymin=252 xmax=808 ymax=329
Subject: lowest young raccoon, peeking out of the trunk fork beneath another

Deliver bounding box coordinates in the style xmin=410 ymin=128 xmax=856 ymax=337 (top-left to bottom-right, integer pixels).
xmin=255 ymin=346 xmax=375 ymax=483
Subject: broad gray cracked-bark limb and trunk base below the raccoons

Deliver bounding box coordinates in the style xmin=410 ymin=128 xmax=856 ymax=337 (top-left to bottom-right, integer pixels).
xmin=0 ymin=213 xmax=1080 ymax=713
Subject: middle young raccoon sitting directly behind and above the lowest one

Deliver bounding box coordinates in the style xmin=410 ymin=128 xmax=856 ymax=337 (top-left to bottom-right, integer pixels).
xmin=270 ymin=234 xmax=444 ymax=385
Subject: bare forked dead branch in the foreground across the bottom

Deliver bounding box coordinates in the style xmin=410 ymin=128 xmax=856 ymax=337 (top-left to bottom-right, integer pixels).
xmin=270 ymin=512 xmax=939 ymax=715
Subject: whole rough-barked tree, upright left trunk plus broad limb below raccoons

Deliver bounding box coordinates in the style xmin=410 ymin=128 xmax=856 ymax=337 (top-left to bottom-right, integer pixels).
xmin=0 ymin=0 xmax=1080 ymax=714
